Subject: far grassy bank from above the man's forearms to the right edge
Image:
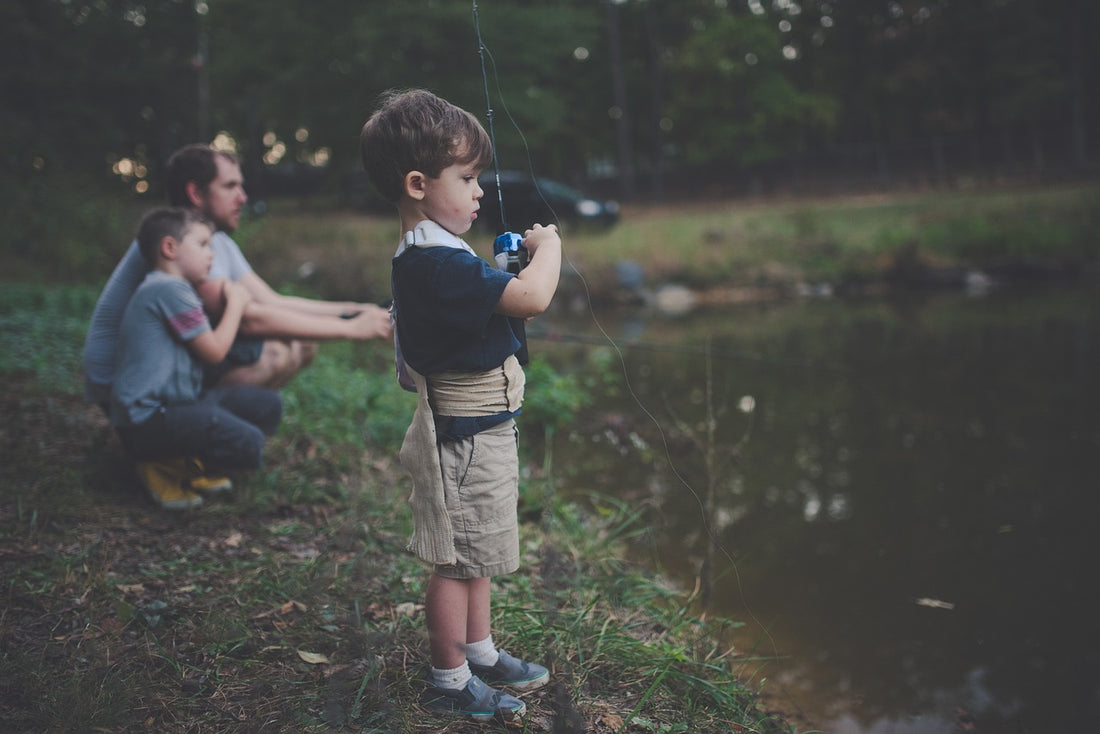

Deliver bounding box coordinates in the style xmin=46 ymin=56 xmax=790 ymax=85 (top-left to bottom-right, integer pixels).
xmin=227 ymin=185 xmax=1100 ymax=299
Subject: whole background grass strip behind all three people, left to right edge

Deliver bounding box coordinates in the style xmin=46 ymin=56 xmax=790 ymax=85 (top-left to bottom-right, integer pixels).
xmin=0 ymin=183 xmax=1100 ymax=302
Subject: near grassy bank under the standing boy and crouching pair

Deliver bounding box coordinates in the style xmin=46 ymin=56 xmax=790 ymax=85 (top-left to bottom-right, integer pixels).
xmin=0 ymin=283 xmax=791 ymax=733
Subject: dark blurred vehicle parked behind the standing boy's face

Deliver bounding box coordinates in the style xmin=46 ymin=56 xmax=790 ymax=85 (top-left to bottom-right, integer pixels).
xmin=477 ymin=171 xmax=619 ymax=234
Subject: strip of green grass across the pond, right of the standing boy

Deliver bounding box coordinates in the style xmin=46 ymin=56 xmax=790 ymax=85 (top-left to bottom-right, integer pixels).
xmin=571 ymin=186 xmax=1100 ymax=287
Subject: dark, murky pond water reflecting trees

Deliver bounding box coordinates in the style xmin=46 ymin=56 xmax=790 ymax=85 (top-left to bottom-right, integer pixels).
xmin=531 ymin=284 xmax=1100 ymax=734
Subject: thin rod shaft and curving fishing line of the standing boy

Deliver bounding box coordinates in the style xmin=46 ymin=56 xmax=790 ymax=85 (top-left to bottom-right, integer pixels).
xmin=472 ymin=0 xmax=779 ymax=699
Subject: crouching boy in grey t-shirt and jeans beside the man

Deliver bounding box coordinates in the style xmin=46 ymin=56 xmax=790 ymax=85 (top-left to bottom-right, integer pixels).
xmin=109 ymin=208 xmax=283 ymax=510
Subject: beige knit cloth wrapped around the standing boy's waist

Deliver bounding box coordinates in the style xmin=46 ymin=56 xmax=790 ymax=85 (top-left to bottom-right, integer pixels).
xmin=427 ymin=355 xmax=525 ymax=416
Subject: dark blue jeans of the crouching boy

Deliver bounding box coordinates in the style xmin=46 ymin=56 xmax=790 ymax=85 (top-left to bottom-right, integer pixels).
xmin=116 ymin=385 xmax=283 ymax=471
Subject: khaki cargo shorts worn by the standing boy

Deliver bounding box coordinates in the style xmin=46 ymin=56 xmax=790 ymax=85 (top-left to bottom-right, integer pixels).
xmin=435 ymin=420 xmax=519 ymax=579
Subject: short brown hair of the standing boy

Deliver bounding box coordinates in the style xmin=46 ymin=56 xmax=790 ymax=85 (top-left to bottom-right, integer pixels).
xmin=359 ymin=89 xmax=493 ymax=204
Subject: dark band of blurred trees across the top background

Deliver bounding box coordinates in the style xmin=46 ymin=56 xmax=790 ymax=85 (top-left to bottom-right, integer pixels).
xmin=0 ymin=0 xmax=1100 ymax=264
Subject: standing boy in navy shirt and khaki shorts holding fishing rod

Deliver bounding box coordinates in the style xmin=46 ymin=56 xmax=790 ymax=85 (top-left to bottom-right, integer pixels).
xmin=360 ymin=90 xmax=561 ymax=720
